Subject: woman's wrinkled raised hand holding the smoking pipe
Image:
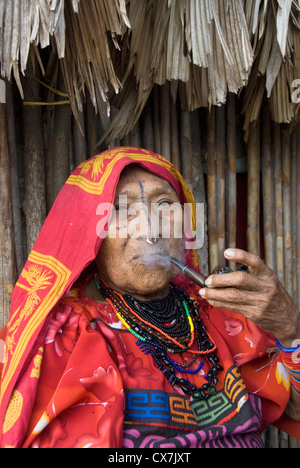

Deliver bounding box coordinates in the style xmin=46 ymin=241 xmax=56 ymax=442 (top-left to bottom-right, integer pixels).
xmin=200 ymin=249 xmax=300 ymax=347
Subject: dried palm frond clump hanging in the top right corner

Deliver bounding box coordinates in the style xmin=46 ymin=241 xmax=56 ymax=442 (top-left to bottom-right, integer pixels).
xmin=244 ymin=0 xmax=300 ymax=138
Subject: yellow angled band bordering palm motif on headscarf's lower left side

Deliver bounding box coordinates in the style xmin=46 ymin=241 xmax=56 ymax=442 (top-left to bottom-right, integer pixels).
xmin=0 ymin=251 xmax=71 ymax=401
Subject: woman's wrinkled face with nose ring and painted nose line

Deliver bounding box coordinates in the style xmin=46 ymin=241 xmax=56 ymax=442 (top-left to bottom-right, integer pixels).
xmin=96 ymin=165 xmax=183 ymax=300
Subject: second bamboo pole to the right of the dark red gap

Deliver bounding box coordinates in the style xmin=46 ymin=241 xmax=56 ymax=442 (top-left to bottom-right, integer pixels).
xmin=262 ymin=103 xmax=275 ymax=270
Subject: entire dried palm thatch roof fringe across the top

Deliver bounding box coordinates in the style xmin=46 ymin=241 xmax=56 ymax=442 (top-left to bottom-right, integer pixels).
xmin=0 ymin=0 xmax=300 ymax=140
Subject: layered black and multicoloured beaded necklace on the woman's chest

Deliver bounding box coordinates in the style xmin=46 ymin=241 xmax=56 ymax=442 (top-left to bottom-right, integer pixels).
xmin=95 ymin=275 xmax=222 ymax=400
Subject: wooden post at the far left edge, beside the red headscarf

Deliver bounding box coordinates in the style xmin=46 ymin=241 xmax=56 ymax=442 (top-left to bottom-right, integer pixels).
xmin=0 ymin=80 xmax=17 ymax=327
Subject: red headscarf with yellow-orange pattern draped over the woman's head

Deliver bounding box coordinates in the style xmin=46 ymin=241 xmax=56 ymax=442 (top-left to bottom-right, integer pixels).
xmin=0 ymin=147 xmax=198 ymax=442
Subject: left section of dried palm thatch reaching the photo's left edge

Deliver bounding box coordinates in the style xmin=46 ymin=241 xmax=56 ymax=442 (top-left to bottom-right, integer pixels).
xmin=0 ymin=0 xmax=130 ymax=113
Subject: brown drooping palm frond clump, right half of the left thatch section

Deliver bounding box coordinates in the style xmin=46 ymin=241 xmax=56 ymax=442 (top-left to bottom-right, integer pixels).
xmin=62 ymin=0 xmax=130 ymax=132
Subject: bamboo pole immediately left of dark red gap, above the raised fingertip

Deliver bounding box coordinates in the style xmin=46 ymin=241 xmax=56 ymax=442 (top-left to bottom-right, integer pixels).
xmin=226 ymin=93 xmax=237 ymax=269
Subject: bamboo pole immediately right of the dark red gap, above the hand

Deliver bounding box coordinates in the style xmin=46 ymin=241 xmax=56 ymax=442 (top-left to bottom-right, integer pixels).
xmin=247 ymin=121 xmax=260 ymax=255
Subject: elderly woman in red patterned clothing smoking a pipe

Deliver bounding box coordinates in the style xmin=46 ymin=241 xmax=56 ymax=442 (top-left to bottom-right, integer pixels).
xmin=0 ymin=148 xmax=300 ymax=448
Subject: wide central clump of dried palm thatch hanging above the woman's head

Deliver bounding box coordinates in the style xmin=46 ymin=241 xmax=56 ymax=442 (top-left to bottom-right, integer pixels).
xmin=102 ymin=0 xmax=253 ymax=141
